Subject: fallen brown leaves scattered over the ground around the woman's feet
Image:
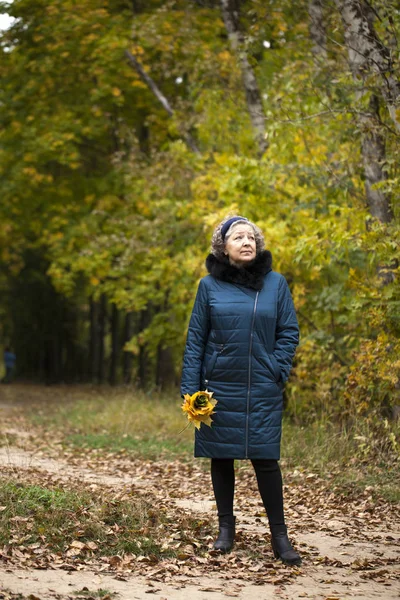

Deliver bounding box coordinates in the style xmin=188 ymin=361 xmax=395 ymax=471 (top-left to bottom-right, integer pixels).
xmin=0 ymin=400 xmax=399 ymax=600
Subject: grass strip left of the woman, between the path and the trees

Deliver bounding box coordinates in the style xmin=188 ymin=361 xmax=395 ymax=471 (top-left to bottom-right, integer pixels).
xmin=29 ymin=387 xmax=194 ymax=460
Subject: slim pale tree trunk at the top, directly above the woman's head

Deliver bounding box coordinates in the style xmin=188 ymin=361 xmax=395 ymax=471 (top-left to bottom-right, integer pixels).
xmin=221 ymin=0 xmax=268 ymax=156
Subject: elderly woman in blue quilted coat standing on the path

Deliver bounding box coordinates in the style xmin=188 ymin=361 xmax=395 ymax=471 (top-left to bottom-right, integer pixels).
xmin=181 ymin=216 xmax=301 ymax=565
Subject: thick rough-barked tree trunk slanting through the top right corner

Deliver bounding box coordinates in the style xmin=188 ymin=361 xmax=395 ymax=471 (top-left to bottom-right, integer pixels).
xmin=335 ymin=0 xmax=400 ymax=133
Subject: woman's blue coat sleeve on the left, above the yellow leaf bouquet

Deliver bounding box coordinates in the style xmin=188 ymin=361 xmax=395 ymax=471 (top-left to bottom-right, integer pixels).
xmin=181 ymin=279 xmax=210 ymax=395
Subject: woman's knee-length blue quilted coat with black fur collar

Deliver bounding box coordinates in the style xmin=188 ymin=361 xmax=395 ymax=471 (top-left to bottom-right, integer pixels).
xmin=181 ymin=250 xmax=299 ymax=459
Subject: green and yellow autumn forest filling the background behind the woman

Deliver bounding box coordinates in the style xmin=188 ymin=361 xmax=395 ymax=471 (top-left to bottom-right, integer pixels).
xmin=0 ymin=0 xmax=400 ymax=450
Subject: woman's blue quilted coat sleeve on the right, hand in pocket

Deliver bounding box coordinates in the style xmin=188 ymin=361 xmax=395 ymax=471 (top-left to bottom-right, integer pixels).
xmin=273 ymin=277 xmax=299 ymax=383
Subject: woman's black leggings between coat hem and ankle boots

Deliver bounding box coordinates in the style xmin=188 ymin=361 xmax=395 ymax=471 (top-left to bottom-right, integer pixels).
xmin=211 ymin=458 xmax=285 ymax=529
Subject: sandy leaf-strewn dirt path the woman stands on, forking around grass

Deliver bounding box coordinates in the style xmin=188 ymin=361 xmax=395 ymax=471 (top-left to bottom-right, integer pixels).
xmin=0 ymin=394 xmax=400 ymax=600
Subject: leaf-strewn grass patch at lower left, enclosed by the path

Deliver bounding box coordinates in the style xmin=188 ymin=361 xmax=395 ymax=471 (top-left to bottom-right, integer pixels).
xmin=0 ymin=479 xmax=177 ymax=556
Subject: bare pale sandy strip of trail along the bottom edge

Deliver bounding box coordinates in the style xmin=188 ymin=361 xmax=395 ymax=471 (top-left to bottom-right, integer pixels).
xmin=0 ymin=570 xmax=399 ymax=600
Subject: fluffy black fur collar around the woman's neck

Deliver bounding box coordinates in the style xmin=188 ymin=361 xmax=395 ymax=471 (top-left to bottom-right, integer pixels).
xmin=206 ymin=250 xmax=272 ymax=291
